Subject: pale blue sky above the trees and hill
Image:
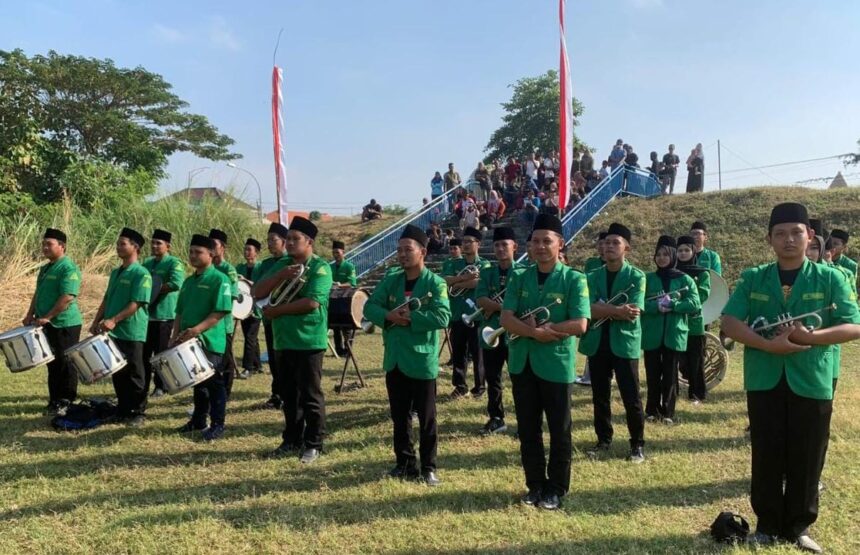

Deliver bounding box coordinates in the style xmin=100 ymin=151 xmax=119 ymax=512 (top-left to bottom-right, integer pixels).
xmin=0 ymin=0 xmax=860 ymax=214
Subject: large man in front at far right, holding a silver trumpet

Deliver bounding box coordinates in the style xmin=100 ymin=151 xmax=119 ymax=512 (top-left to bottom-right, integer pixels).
xmin=722 ymin=203 xmax=860 ymax=553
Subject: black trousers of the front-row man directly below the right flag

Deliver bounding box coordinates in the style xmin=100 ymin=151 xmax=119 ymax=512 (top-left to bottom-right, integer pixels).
xmin=511 ymin=362 xmax=573 ymax=495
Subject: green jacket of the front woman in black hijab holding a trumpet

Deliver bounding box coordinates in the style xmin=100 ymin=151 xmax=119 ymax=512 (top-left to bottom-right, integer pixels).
xmin=640 ymin=272 xmax=702 ymax=351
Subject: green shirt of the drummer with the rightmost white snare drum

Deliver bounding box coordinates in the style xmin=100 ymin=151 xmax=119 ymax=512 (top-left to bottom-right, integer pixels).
xmin=176 ymin=265 xmax=233 ymax=355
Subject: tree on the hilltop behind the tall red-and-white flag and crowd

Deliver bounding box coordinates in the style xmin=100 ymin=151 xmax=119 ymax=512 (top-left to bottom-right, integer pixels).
xmin=484 ymin=70 xmax=586 ymax=162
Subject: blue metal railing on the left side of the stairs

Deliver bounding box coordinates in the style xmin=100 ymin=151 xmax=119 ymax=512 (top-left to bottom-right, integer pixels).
xmin=346 ymin=181 xmax=471 ymax=278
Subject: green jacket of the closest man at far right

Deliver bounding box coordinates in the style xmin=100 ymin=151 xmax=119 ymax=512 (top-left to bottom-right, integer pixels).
xmin=723 ymin=260 xmax=860 ymax=400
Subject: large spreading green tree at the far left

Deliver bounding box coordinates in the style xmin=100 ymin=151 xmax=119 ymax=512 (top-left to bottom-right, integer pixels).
xmin=0 ymin=50 xmax=240 ymax=201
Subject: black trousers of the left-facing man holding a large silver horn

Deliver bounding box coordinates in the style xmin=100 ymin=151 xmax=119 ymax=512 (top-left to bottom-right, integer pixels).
xmin=275 ymin=349 xmax=325 ymax=450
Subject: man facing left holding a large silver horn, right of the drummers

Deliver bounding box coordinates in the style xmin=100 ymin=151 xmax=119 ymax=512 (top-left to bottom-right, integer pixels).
xmin=254 ymin=216 xmax=332 ymax=464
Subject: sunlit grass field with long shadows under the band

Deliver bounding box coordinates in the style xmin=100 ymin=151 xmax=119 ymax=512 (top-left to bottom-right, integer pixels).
xmin=0 ymin=335 xmax=860 ymax=554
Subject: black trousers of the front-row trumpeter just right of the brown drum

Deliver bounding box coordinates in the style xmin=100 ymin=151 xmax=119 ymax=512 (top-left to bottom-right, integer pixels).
xmin=385 ymin=367 xmax=439 ymax=472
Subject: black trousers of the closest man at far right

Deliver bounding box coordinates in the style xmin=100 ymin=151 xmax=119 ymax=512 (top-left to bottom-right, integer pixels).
xmin=747 ymin=375 xmax=833 ymax=540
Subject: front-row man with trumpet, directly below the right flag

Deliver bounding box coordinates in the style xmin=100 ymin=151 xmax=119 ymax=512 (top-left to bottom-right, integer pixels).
xmin=501 ymin=214 xmax=591 ymax=510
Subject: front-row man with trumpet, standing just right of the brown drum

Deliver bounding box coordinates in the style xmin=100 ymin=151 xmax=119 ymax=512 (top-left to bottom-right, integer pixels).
xmin=364 ymin=224 xmax=451 ymax=486
